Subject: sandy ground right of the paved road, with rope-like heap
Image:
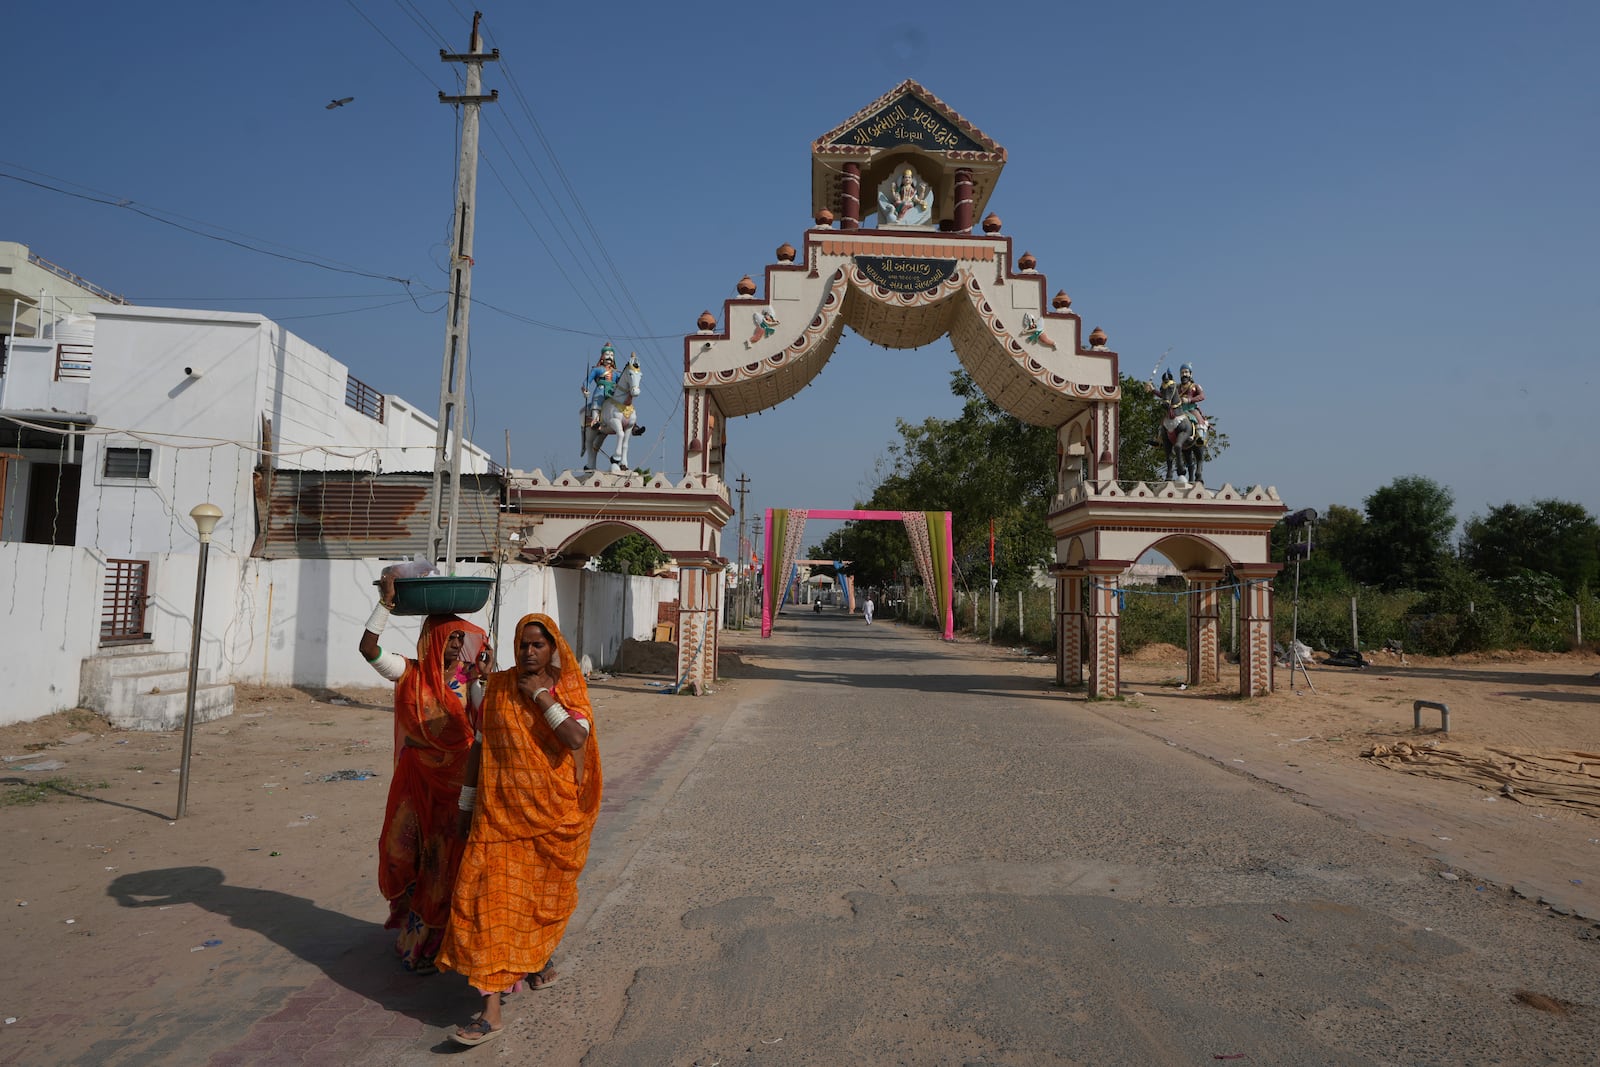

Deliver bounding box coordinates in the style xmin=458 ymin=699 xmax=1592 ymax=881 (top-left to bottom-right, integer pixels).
xmin=1090 ymin=646 xmax=1600 ymax=920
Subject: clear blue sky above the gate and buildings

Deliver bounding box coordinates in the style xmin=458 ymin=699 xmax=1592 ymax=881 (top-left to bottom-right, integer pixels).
xmin=0 ymin=0 xmax=1600 ymax=559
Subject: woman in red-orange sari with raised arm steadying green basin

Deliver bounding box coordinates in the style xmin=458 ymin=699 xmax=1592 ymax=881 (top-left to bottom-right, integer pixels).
xmin=360 ymin=574 xmax=486 ymax=974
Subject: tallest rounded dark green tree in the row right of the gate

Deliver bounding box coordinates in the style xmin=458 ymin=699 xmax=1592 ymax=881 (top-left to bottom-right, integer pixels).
xmin=1358 ymin=475 xmax=1456 ymax=590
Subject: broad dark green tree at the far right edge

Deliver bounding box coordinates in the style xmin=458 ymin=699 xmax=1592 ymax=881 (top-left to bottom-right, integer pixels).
xmin=1461 ymin=499 xmax=1600 ymax=595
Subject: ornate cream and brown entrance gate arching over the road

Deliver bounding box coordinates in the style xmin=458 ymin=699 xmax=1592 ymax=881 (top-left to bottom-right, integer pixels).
xmin=515 ymin=80 xmax=1288 ymax=696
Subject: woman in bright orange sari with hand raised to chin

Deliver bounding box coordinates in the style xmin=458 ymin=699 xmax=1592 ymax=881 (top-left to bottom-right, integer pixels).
xmin=438 ymin=614 xmax=600 ymax=1045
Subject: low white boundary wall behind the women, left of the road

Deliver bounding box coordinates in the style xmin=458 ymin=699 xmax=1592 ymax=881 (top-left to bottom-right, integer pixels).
xmin=0 ymin=542 xmax=678 ymax=725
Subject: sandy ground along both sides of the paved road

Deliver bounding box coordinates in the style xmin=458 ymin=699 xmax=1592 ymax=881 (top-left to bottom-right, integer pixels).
xmin=0 ymin=635 xmax=1600 ymax=1062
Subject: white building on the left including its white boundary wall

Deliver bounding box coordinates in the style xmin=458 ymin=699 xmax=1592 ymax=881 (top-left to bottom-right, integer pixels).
xmin=0 ymin=243 xmax=675 ymax=728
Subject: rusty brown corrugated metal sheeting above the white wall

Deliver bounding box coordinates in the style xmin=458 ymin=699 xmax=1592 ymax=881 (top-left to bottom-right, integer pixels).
xmin=253 ymin=469 xmax=502 ymax=560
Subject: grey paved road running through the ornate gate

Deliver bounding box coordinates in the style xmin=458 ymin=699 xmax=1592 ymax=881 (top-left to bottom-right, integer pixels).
xmin=28 ymin=613 xmax=1600 ymax=1067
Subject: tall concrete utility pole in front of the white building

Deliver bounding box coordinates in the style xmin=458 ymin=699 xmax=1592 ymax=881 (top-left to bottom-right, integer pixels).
xmin=427 ymin=11 xmax=499 ymax=574
